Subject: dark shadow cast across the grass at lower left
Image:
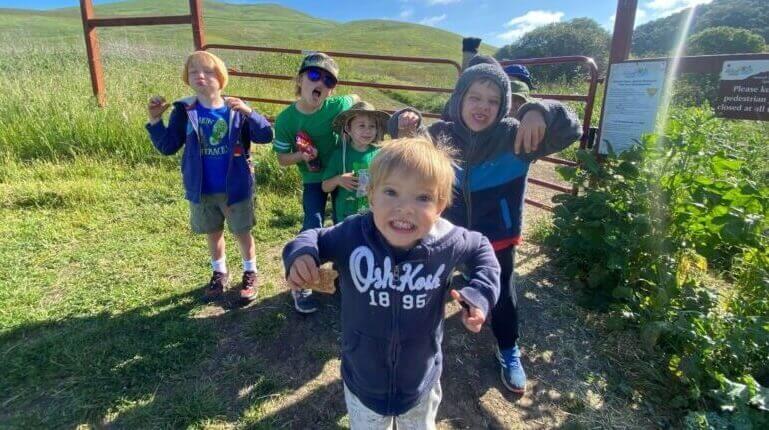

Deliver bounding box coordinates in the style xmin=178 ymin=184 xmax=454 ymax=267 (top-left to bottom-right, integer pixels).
xmin=0 ymin=282 xmax=344 ymax=428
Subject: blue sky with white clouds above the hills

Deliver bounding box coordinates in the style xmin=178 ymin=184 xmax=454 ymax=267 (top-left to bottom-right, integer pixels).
xmin=0 ymin=0 xmax=712 ymax=46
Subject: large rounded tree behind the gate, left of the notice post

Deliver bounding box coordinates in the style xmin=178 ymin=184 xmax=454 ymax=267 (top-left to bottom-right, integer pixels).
xmin=494 ymin=18 xmax=610 ymax=81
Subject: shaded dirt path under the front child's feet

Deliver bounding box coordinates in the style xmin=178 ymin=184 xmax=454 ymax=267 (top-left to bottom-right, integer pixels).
xmin=186 ymin=164 xmax=665 ymax=429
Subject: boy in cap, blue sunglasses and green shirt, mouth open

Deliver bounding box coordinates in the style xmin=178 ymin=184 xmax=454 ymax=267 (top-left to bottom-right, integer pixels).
xmin=272 ymin=52 xmax=360 ymax=314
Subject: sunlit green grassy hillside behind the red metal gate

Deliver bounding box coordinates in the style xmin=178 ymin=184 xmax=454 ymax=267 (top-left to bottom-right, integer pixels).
xmin=0 ymin=0 xmax=494 ymax=93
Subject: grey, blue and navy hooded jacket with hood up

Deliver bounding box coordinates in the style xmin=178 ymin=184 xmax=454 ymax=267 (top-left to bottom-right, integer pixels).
xmin=388 ymin=64 xmax=582 ymax=250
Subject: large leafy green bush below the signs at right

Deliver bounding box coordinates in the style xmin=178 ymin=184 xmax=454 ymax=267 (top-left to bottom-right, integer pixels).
xmin=549 ymin=105 xmax=769 ymax=428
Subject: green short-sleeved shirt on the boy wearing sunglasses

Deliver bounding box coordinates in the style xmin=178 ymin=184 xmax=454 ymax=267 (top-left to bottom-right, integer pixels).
xmin=272 ymin=96 xmax=353 ymax=184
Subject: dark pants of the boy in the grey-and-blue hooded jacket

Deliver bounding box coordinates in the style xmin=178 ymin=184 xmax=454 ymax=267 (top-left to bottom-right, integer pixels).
xmin=491 ymin=246 xmax=518 ymax=349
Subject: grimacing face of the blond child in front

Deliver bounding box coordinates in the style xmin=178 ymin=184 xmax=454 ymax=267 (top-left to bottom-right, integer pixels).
xmin=369 ymin=170 xmax=445 ymax=250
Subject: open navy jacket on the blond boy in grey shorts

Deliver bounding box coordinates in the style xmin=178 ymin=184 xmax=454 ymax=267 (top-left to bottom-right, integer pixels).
xmin=146 ymin=96 xmax=272 ymax=205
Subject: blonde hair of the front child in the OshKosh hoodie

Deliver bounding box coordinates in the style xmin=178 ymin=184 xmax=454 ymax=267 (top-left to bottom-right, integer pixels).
xmin=369 ymin=136 xmax=454 ymax=210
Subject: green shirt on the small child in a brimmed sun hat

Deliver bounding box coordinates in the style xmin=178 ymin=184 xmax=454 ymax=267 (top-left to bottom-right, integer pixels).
xmin=323 ymin=144 xmax=379 ymax=222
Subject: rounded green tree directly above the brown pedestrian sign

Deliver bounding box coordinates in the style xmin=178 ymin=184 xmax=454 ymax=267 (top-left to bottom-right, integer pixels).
xmin=686 ymin=26 xmax=766 ymax=55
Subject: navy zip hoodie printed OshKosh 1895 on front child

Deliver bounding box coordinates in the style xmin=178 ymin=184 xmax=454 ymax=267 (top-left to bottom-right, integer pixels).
xmin=283 ymin=213 xmax=500 ymax=416
